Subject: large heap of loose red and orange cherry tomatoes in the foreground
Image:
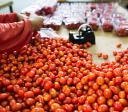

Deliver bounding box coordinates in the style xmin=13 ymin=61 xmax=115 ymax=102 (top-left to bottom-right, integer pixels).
xmin=0 ymin=34 xmax=128 ymax=112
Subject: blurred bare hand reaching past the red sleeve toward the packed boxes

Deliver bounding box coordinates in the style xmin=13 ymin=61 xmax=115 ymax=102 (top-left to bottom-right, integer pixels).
xmin=29 ymin=14 xmax=43 ymax=31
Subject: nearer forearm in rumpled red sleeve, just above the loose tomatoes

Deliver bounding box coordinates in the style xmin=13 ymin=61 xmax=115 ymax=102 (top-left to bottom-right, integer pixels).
xmin=0 ymin=19 xmax=32 ymax=53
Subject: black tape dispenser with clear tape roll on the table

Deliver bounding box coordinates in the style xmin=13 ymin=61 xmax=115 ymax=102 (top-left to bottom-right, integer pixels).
xmin=69 ymin=24 xmax=95 ymax=44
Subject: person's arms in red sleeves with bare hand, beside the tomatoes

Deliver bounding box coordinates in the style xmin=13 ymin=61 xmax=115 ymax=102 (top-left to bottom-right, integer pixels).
xmin=0 ymin=13 xmax=43 ymax=53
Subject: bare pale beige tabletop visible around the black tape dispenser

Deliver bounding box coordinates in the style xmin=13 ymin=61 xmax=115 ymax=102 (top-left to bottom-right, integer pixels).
xmin=58 ymin=4 xmax=128 ymax=63
